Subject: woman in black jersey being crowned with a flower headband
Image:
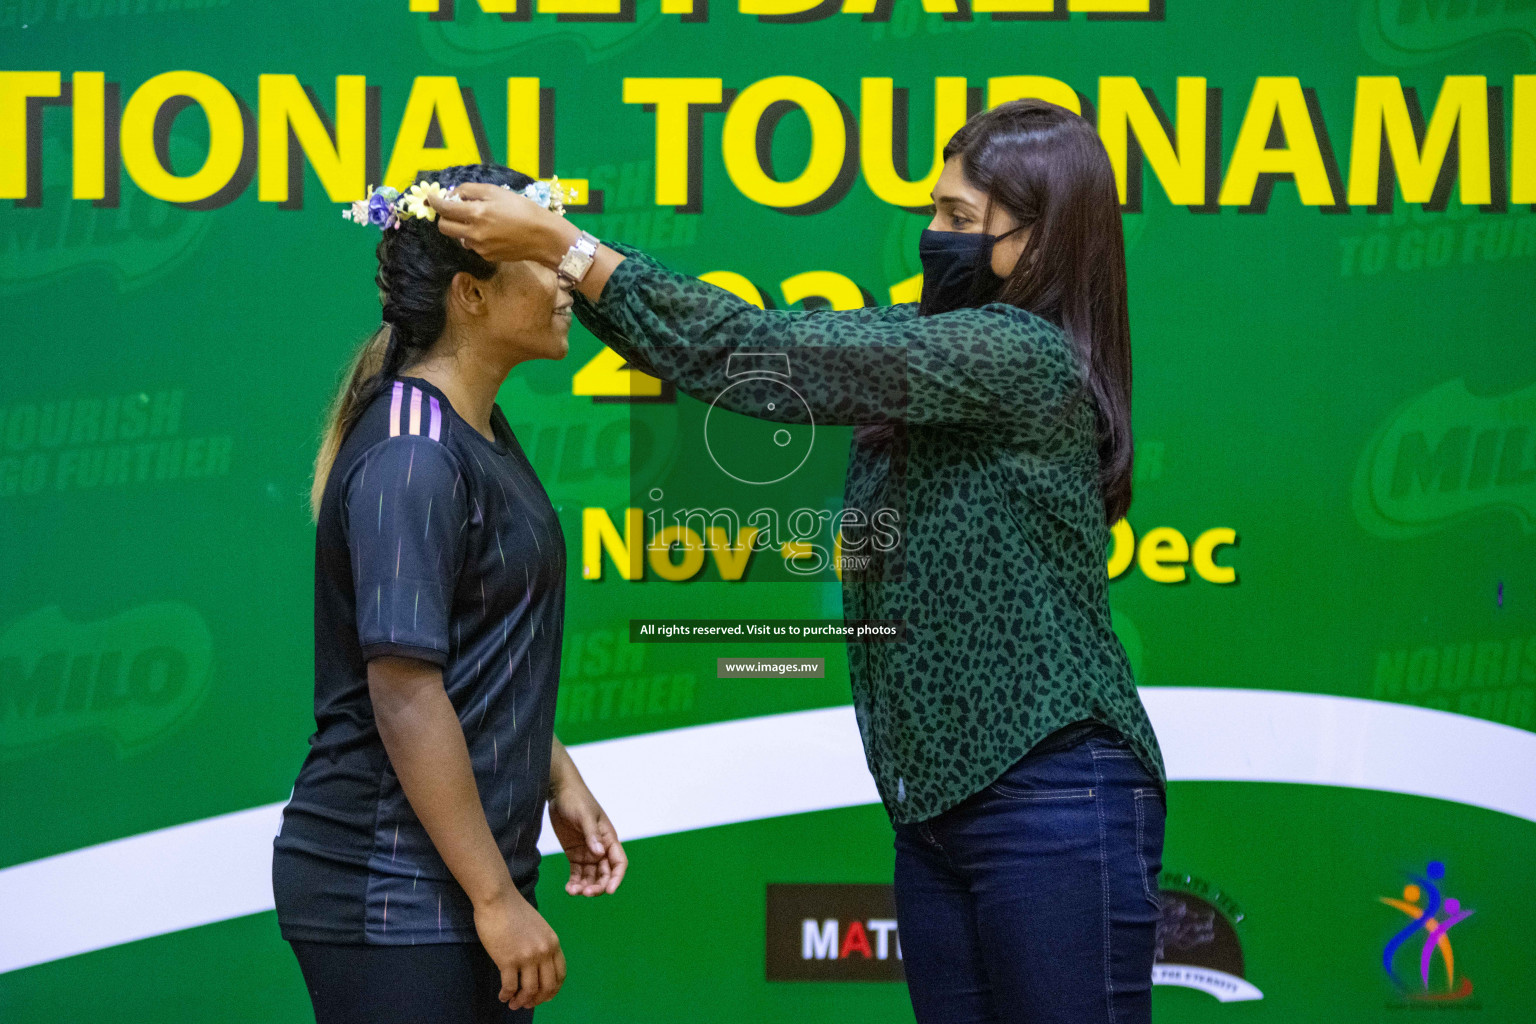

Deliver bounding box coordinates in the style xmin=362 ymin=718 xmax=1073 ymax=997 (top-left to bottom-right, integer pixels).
xmin=272 ymin=166 xmax=627 ymax=1024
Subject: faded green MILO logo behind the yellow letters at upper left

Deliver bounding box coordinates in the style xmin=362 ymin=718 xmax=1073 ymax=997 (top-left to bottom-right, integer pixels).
xmin=0 ymin=132 xmax=209 ymax=290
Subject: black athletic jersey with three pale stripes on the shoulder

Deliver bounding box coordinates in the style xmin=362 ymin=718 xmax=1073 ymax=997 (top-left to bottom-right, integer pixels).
xmin=272 ymin=378 xmax=565 ymax=944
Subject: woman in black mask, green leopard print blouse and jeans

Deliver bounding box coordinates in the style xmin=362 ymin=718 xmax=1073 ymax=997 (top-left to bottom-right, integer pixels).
xmin=435 ymin=100 xmax=1166 ymax=1024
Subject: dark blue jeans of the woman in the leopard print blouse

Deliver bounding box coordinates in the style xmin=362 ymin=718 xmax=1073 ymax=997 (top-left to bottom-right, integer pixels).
xmin=895 ymin=728 xmax=1166 ymax=1024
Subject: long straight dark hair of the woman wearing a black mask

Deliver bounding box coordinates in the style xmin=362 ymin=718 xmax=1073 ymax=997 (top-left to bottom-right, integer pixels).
xmin=945 ymin=100 xmax=1134 ymax=524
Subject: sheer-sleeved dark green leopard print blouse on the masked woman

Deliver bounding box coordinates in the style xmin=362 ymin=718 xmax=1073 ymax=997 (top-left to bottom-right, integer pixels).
xmin=576 ymin=246 xmax=1166 ymax=823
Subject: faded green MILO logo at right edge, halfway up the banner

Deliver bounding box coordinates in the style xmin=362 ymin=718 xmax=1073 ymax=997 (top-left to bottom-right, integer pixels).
xmin=1355 ymin=379 xmax=1536 ymax=537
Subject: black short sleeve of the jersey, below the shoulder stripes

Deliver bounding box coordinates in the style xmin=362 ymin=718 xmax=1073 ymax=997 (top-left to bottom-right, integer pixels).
xmin=346 ymin=434 xmax=468 ymax=665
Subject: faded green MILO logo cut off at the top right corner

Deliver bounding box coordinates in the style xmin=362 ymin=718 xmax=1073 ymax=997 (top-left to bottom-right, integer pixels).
xmin=1359 ymin=0 xmax=1536 ymax=66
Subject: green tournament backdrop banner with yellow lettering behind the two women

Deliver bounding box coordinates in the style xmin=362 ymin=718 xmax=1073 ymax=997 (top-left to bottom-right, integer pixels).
xmin=0 ymin=0 xmax=1536 ymax=1024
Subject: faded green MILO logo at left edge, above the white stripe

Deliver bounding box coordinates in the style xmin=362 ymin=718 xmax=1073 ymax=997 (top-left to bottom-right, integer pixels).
xmin=0 ymin=602 xmax=214 ymax=758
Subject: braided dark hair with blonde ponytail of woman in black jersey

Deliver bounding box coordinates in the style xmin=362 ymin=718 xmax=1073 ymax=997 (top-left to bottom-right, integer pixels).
xmin=309 ymin=164 xmax=533 ymax=519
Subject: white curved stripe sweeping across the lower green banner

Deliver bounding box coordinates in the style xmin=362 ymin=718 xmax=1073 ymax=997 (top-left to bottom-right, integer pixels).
xmin=0 ymin=686 xmax=1536 ymax=973
